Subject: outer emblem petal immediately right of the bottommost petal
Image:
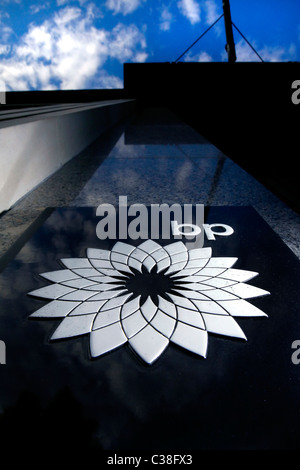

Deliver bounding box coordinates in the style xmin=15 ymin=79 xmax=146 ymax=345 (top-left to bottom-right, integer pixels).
xmin=170 ymin=322 xmax=207 ymax=357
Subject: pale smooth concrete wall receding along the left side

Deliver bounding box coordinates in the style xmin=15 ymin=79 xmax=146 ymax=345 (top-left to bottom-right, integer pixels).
xmin=0 ymin=100 xmax=134 ymax=213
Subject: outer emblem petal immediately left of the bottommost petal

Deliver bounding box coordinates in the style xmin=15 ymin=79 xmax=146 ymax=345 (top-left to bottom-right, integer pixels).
xmin=90 ymin=322 xmax=127 ymax=357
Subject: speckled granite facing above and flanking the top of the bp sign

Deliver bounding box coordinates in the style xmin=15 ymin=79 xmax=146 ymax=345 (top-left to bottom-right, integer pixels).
xmin=0 ymin=109 xmax=300 ymax=258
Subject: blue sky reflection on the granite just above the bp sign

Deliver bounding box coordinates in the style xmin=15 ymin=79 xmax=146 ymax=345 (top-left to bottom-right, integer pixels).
xmin=72 ymin=157 xmax=217 ymax=206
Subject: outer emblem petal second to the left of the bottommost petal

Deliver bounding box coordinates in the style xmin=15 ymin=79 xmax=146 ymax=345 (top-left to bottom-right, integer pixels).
xmin=51 ymin=314 xmax=96 ymax=339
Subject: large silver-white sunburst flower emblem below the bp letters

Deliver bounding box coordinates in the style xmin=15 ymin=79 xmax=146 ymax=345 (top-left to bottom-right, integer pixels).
xmin=29 ymin=240 xmax=269 ymax=364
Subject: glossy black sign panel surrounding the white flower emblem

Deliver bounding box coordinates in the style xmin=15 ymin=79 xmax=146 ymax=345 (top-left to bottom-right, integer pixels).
xmin=0 ymin=207 xmax=300 ymax=455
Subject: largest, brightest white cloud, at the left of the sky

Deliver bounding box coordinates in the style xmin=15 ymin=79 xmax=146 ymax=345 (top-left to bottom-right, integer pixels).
xmin=0 ymin=7 xmax=147 ymax=90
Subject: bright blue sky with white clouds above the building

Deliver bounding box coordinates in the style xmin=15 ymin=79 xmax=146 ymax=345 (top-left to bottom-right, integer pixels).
xmin=0 ymin=0 xmax=300 ymax=91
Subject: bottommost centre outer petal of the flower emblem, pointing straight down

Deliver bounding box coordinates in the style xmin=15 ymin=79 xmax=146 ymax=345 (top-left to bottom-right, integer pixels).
xmin=129 ymin=325 xmax=169 ymax=364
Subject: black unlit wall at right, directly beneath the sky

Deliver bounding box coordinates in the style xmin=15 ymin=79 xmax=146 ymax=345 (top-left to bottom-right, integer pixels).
xmin=124 ymin=62 xmax=300 ymax=211
